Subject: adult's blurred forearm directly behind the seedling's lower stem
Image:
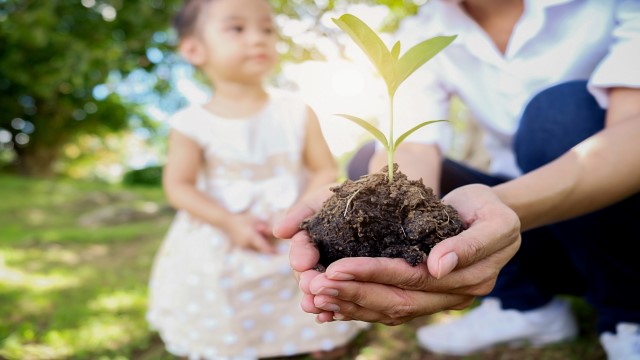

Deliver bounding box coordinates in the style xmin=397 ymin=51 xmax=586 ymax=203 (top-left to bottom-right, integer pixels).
xmin=369 ymin=143 xmax=442 ymax=194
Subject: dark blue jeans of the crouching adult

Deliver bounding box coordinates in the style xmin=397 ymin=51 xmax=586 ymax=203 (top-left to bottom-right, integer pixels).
xmin=348 ymin=81 xmax=640 ymax=332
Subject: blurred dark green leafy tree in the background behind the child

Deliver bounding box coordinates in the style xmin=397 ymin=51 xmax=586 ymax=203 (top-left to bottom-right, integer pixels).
xmin=0 ymin=0 xmax=420 ymax=176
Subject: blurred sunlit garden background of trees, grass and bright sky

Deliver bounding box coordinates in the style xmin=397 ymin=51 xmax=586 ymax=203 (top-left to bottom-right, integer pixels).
xmin=0 ymin=0 xmax=603 ymax=359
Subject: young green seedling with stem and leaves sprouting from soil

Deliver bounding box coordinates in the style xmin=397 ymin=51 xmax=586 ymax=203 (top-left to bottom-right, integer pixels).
xmin=332 ymin=14 xmax=456 ymax=183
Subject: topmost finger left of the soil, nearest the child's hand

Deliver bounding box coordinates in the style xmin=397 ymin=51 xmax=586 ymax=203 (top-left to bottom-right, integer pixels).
xmin=273 ymin=187 xmax=332 ymax=239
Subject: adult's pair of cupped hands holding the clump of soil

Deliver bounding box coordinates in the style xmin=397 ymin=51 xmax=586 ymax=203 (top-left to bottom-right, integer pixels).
xmin=274 ymin=185 xmax=520 ymax=325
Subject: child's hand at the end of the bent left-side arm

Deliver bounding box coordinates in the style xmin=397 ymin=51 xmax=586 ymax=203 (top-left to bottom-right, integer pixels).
xmin=224 ymin=213 xmax=276 ymax=254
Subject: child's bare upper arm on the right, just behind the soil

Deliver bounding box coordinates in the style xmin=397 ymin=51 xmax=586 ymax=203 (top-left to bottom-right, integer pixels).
xmin=300 ymin=108 xmax=338 ymax=199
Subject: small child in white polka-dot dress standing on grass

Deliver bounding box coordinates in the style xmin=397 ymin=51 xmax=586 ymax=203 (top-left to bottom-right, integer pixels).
xmin=147 ymin=0 xmax=361 ymax=359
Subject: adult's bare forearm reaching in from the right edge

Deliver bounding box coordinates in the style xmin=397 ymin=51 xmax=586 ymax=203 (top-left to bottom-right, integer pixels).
xmin=494 ymin=118 xmax=640 ymax=230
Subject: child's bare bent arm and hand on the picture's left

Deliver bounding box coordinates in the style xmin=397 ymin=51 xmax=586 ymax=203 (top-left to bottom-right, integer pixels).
xmin=162 ymin=130 xmax=275 ymax=252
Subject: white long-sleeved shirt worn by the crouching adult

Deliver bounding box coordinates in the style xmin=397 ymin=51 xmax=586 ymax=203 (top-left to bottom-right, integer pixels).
xmin=395 ymin=0 xmax=640 ymax=177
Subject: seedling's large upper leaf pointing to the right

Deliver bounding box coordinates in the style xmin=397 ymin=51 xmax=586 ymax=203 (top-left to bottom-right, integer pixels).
xmin=395 ymin=35 xmax=457 ymax=87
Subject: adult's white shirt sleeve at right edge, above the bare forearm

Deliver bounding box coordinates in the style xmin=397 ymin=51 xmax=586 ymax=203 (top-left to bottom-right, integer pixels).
xmin=588 ymin=0 xmax=640 ymax=109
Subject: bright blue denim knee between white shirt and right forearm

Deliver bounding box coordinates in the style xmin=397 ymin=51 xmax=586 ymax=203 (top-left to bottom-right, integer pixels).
xmin=513 ymin=80 xmax=605 ymax=173
